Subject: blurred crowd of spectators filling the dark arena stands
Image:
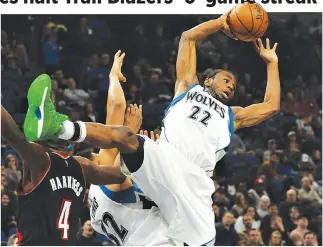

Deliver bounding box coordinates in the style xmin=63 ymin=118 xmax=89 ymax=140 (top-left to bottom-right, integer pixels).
xmin=1 ymin=13 xmax=322 ymax=246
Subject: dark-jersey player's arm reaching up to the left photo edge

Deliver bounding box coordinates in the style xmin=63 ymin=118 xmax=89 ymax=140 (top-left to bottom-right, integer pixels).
xmin=1 ymin=106 xmax=49 ymax=177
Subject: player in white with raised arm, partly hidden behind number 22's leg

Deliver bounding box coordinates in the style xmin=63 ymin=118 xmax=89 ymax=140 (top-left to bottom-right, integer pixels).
xmin=88 ymin=52 xmax=168 ymax=246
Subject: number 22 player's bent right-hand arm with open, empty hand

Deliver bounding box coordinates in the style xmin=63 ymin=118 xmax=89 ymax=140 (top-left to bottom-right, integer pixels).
xmin=232 ymin=39 xmax=280 ymax=129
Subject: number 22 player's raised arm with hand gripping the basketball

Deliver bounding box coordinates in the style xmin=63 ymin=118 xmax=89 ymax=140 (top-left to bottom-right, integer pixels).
xmin=175 ymin=14 xmax=232 ymax=97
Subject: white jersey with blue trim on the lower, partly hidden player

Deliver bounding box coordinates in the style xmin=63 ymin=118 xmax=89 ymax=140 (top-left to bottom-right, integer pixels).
xmin=88 ymin=182 xmax=168 ymax=246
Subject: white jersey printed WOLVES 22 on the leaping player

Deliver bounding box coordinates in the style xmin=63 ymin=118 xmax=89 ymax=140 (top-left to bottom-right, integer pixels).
xmin=161 ymin=84 xmax=234 ymax=176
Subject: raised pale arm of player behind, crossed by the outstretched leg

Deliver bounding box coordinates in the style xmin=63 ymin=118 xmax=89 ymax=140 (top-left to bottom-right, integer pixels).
xmin=97 ymin=50 xmax=126 ymax=165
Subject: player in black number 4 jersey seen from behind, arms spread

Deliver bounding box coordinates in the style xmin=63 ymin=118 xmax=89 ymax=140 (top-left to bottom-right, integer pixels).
xmin=1 ymin=53 xmax=135 ymax=245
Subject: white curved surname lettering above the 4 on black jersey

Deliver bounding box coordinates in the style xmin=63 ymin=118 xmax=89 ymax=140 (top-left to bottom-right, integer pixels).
xmin=49 ymin=176 xmax=84 ymax=196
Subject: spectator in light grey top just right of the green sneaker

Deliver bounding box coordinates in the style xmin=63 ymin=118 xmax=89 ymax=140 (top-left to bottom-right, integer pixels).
xmin=64 ymin=77 xmax=89 ymax=107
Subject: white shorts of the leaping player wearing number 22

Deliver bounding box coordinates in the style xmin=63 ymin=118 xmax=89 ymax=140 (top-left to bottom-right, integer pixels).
xmin=121 ymin=137 xmax=215 ymax=245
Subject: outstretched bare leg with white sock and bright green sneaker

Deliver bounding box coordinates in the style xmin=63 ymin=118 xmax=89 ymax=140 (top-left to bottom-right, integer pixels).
xmin=24 ymin=75 xmax=138 ymax=153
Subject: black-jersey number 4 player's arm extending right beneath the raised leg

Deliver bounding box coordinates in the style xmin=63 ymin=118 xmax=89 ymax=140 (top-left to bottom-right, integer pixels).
xmin=74 ymin=156 xmax=126 ymax=185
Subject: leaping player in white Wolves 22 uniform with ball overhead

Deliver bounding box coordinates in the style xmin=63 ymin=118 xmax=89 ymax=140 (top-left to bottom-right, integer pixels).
xmin=27 ymin=9 xmax=280 ymax=245
